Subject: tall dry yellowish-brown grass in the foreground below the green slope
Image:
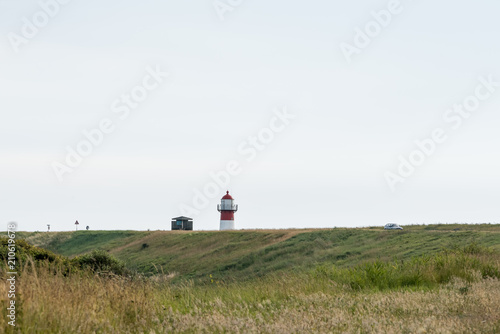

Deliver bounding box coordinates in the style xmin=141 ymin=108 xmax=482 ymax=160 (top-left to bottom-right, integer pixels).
xmin=0 ymin=261 xmax=500 ymax=333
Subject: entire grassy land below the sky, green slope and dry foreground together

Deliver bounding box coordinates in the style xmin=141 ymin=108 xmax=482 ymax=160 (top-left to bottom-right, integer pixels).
xmin=0 ymin=225 xmax=500 ymax=333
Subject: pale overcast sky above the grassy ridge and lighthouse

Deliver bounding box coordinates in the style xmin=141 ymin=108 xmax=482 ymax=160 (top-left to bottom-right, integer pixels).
xmin=0 ymin=0 xmax=500 ymax=231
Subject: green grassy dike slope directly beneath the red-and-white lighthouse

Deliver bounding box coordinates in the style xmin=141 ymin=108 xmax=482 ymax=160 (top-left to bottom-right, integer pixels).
xmin=19 ymin=224 xmax=500 ymax=280
